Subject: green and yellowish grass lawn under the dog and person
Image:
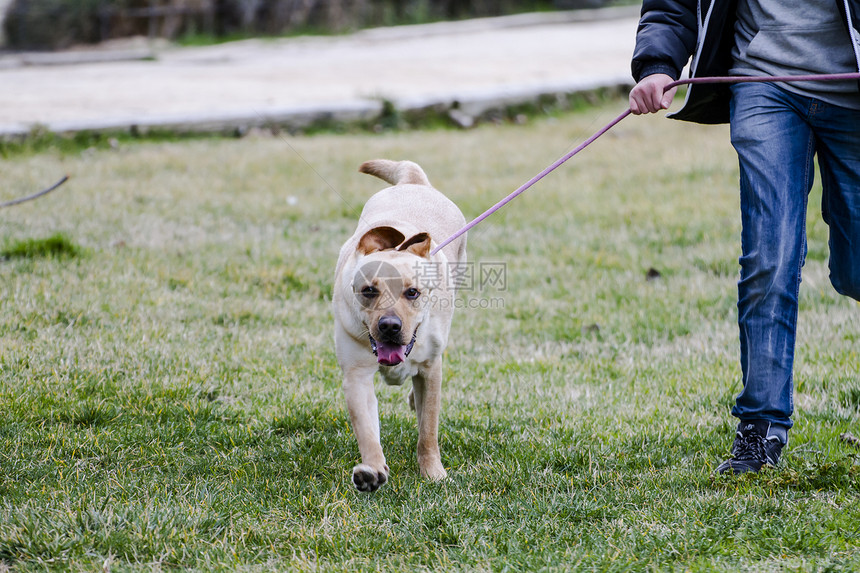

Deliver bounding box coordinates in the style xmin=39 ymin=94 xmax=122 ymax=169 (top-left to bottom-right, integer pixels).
xmin=0 ymin=102 xmax=860 ymax=571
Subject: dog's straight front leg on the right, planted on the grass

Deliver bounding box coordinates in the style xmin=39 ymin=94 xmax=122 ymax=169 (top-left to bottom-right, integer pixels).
xmin=412 ymin=358 xmax=448 ymax=481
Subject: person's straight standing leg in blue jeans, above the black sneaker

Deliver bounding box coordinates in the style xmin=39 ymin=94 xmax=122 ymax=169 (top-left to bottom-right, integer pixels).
xmin=731 ymin=84 xmax=815 ymax=433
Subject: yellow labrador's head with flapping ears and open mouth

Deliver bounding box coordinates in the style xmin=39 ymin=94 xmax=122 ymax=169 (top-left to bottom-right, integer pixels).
xmin=352 ymin=227 xmax=434 ymax=366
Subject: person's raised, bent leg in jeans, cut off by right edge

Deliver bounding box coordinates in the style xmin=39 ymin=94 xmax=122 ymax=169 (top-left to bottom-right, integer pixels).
xmin=812 ymin=105 xmax=860 ymax=300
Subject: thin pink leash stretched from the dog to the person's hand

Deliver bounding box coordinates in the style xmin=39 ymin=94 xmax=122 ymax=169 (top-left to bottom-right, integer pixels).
xmin=430 ymin=73 xmax=860 ymax=255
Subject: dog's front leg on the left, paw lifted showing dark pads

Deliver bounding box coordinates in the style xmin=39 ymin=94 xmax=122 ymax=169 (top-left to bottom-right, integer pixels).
xmin=343 ymin=368 xmax=388 ymax=491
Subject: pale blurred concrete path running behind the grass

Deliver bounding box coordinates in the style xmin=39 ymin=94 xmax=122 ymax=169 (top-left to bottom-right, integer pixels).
xmin=0 ymin=7 xmax=638 ymax=137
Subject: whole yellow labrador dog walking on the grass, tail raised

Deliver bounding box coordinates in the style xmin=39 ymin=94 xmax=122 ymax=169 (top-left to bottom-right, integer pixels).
xmin=332 ymin=159 xmax=466 ymax=491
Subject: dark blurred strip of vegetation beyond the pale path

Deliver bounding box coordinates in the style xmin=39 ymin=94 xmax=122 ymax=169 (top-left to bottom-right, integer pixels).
xmin=0 ymin=0 xmax=632 ymax=51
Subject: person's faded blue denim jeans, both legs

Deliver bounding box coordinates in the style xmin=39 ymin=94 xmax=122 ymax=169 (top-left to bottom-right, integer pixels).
xmin=731 ymin=83 xmax=860 ymax=428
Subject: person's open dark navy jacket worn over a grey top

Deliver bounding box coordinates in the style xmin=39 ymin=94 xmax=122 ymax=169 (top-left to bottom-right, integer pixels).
xmin=632 ymin=0 xmax=860 ymax=123
